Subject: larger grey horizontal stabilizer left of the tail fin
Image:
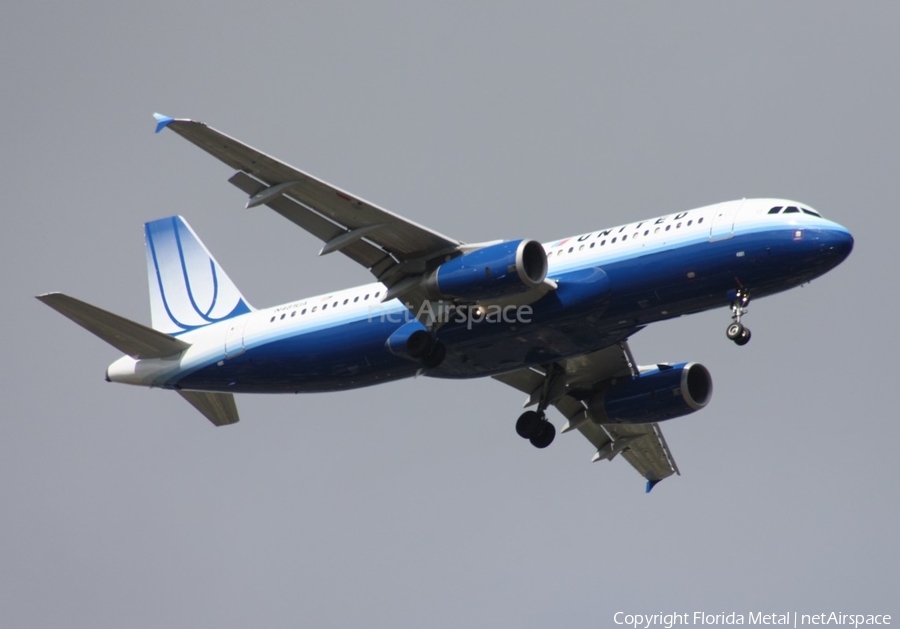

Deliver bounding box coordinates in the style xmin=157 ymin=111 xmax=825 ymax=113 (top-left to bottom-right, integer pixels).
xmin=37 ymin=293 xmax=190 ymax=359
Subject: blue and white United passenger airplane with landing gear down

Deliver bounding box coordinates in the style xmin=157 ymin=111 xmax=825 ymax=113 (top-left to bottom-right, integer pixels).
xmin=37 ymin=114 xmax=853 ymax=492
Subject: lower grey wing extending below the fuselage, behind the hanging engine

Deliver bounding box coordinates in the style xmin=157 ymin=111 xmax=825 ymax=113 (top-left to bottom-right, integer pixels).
xmin=494 ymin=341 xmax=680 ymax=492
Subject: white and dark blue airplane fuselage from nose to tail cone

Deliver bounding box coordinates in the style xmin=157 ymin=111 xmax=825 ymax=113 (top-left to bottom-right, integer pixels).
xmin=107 ymin=199 xmax=853 ymax=393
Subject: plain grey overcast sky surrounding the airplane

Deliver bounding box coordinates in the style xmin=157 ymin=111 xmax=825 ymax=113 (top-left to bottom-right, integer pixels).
xmin=0 ymin=0 xmax=900 ymax=627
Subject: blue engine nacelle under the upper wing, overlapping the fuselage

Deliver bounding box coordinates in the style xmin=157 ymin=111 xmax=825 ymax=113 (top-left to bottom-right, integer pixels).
xmin=425 ymin=240 xmax=547 ymax=300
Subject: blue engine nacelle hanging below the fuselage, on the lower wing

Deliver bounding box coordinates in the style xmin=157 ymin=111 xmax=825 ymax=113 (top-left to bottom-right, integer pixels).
xmin=588 ymin=363 xmax=712 ymax=424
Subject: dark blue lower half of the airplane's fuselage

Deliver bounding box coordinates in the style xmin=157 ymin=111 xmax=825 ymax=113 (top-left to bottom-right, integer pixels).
xmin=168 ymin=225 xmax=852 ymax=393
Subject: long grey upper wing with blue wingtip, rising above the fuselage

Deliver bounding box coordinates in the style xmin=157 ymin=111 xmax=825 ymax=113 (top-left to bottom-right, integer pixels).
xmin=155 ymin=114 xmax=463 ymax=301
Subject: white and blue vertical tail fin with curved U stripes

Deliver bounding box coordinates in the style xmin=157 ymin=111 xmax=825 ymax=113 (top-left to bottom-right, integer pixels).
xmin=144 ymin=216 xmax=253 ymax=334
